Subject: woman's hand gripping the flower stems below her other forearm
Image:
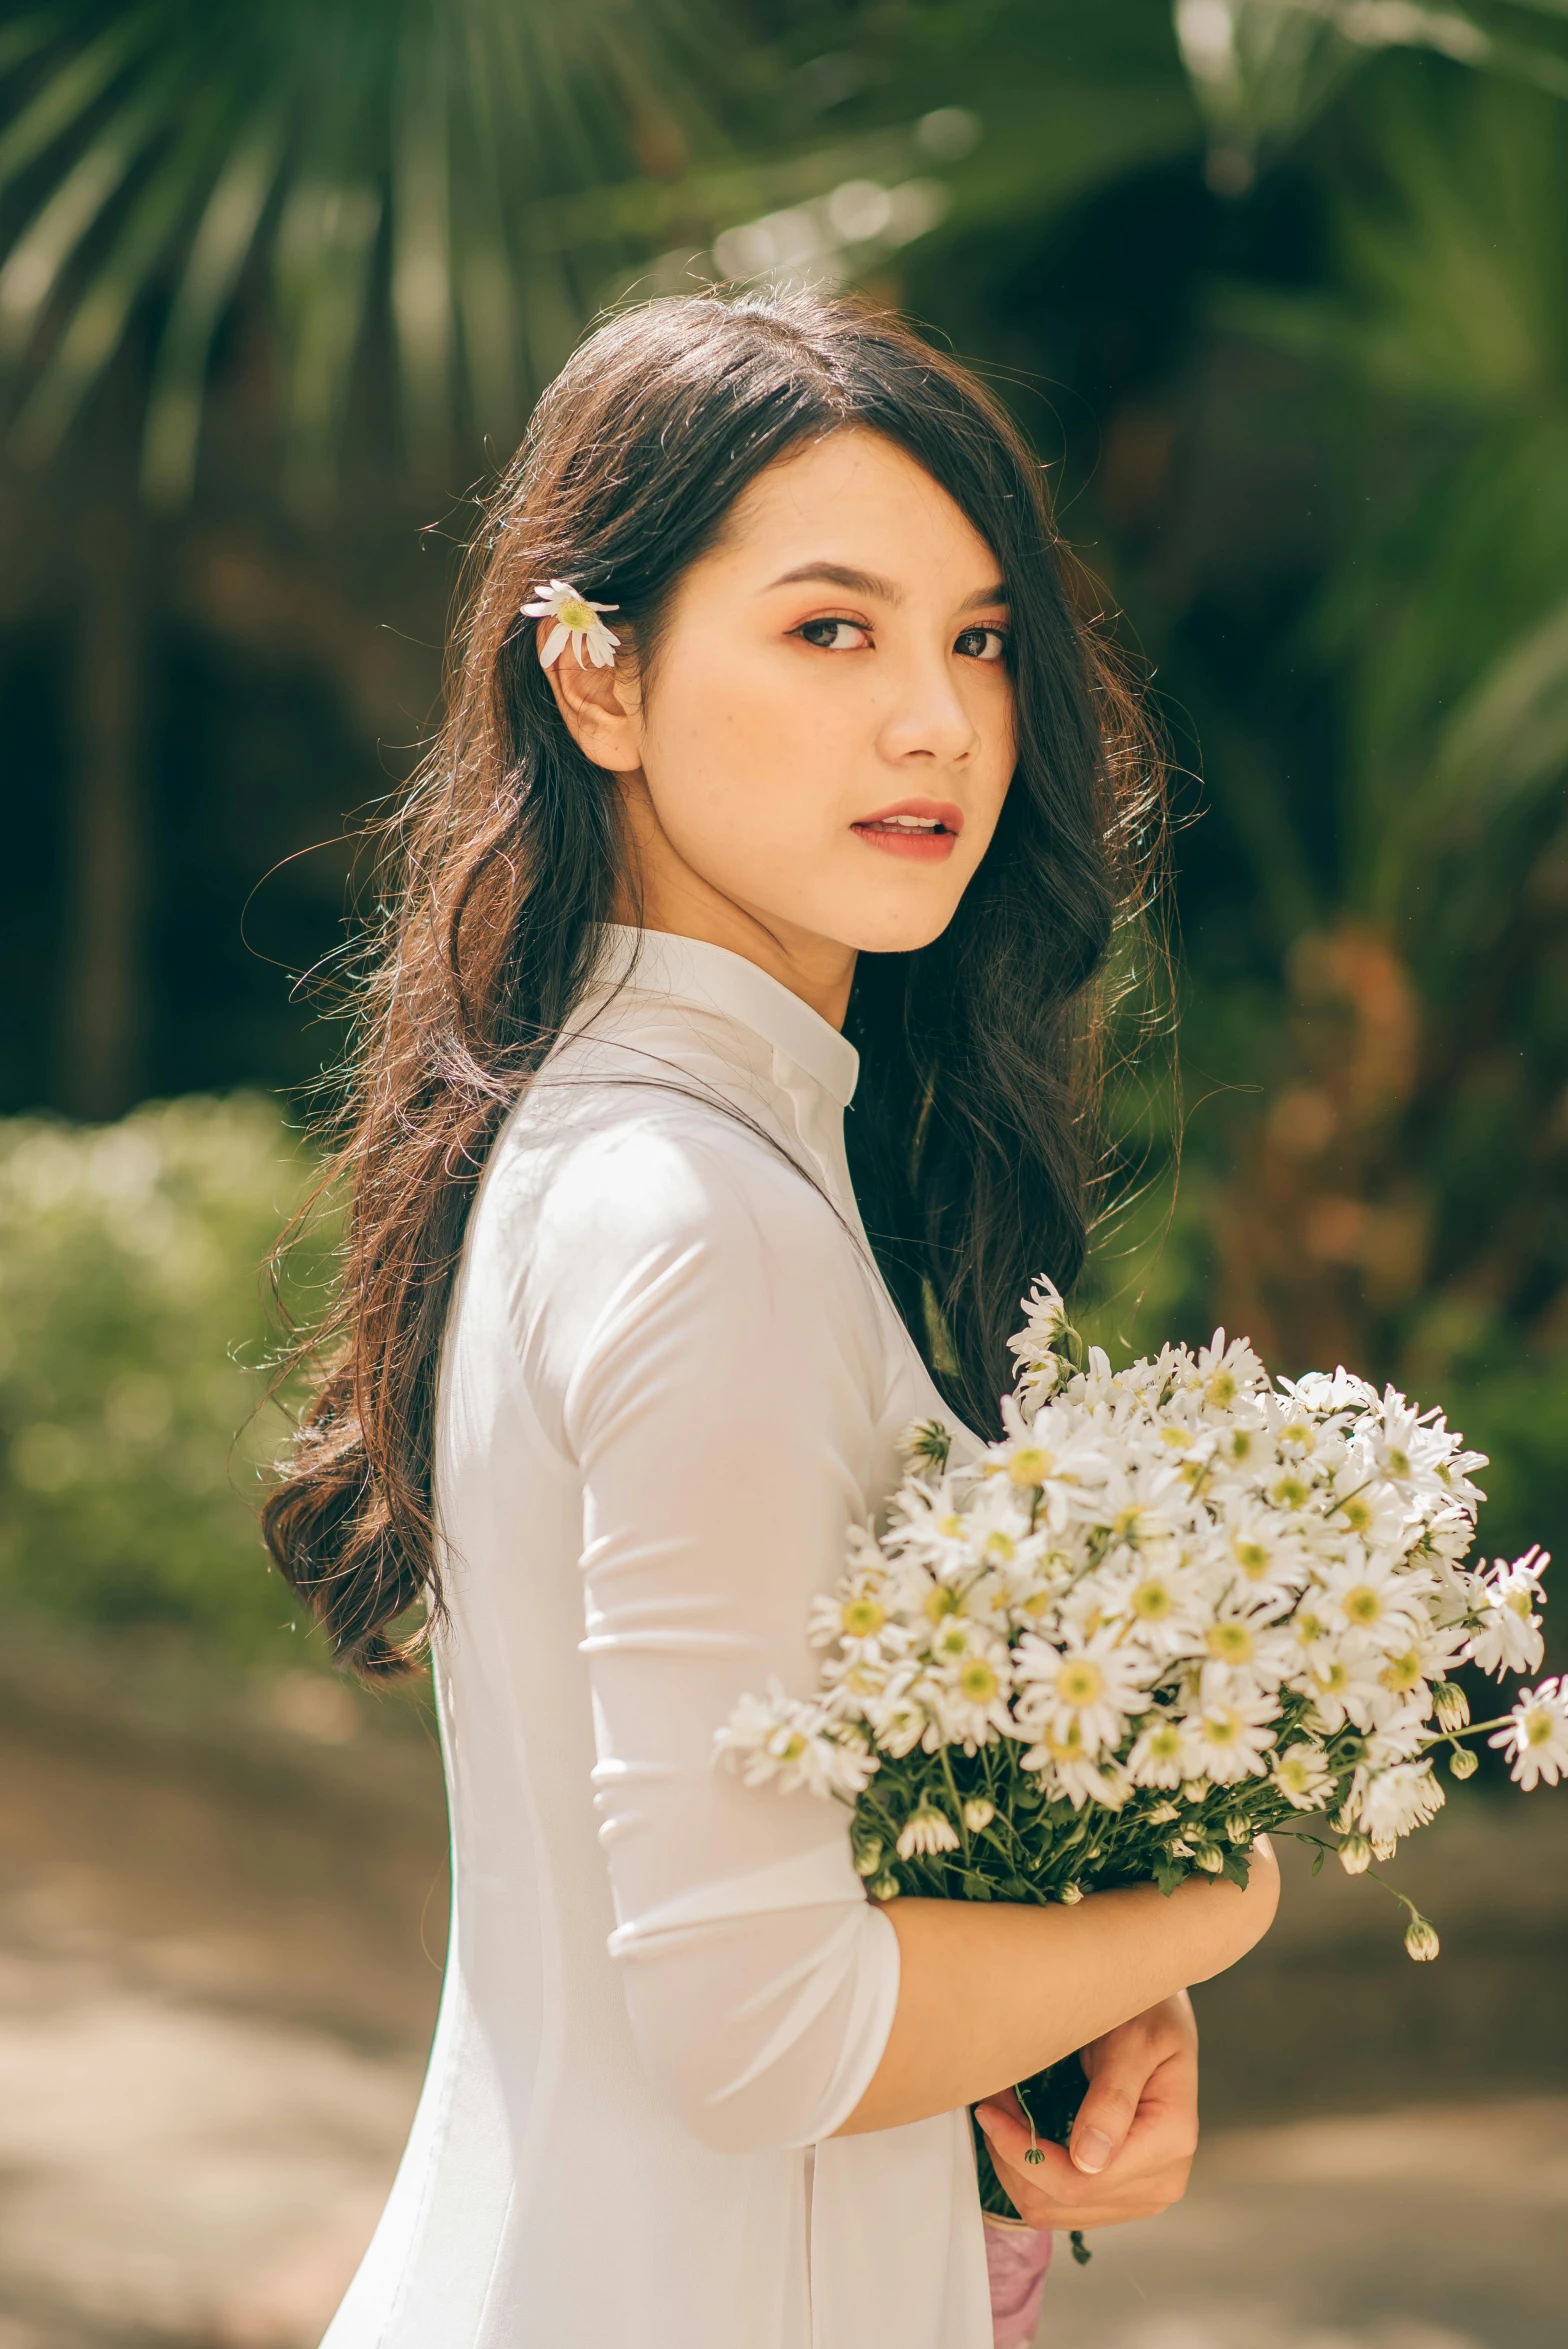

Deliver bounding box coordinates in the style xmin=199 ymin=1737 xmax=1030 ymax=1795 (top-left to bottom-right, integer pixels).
xmin=974 ymin=1990 xmax=1197 ymax=2227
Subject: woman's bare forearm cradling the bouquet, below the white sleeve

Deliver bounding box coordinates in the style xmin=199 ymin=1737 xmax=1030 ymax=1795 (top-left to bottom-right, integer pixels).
xmin=838 ymin=1844 xmax=1279 ymax=2138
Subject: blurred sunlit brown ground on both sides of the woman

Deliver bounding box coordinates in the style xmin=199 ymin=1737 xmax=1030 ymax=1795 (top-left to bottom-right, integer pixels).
xmin=0 ymin=1681 xmax=1568 ymax=2349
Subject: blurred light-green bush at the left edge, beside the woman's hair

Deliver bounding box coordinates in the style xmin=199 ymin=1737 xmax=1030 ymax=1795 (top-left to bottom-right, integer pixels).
xmin=0 ymin=1095 xmax=324 ymax=1668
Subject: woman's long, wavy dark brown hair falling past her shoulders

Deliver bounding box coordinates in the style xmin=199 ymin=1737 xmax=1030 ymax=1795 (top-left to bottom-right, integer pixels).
xmin=263 ymin=296 xmax=1160 ymax=1677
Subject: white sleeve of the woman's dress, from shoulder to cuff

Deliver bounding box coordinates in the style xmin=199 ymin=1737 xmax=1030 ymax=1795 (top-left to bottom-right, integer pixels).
xmin=516 ymin=1113 xmax=899 ymax=2152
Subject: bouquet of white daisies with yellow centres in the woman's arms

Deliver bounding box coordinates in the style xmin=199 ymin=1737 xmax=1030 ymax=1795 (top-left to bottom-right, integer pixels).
xmin=718 ymin=1283 xmax=1568 ymax=2210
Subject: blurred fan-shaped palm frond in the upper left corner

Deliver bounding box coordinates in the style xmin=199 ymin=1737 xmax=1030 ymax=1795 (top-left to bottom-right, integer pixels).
xmin=0 ymin=0 xmax=739 ymax=503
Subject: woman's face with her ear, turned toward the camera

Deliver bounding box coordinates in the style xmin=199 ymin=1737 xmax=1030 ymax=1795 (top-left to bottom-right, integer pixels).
xmin=552 ymin=430 xmax=1014 ymax=1017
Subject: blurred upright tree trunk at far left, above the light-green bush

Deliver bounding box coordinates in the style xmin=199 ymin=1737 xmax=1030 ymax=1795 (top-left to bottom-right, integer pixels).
xmin=56 ymin=500 xmax=148 ymax=1118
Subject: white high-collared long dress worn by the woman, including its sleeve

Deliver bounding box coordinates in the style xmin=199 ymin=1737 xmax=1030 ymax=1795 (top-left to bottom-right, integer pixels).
xmin=326 ymin=930 xmax=991 ymax=2349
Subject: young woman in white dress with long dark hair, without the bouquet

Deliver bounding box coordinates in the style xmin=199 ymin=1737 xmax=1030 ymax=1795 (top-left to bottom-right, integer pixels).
xmin=268 ymin=298 xmax=1275 ymax=2349
